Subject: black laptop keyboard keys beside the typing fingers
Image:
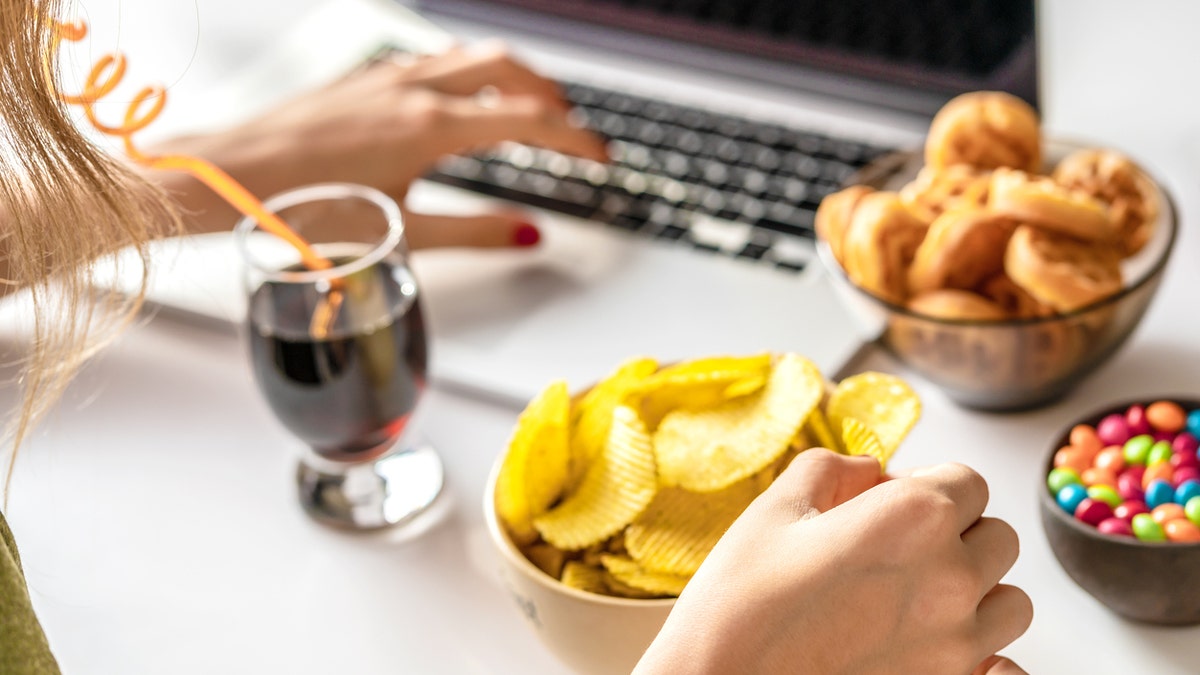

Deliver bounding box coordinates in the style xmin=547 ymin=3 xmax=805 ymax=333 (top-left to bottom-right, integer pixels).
xmin=427 ymin=83 xmax=890 ymax=271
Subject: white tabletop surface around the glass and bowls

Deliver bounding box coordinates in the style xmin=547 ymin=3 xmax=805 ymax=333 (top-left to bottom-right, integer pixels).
xmin=7 ymin=0 xmax=1200 ymax=675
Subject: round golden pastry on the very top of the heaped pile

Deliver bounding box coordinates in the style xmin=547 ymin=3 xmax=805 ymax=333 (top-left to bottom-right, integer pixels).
xmin=925 ymin=91 xmax=1042 ymax=173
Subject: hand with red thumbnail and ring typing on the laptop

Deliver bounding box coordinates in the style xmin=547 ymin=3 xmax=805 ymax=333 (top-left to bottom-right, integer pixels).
xmin=151 ymin=43 xmax=606 ymax=249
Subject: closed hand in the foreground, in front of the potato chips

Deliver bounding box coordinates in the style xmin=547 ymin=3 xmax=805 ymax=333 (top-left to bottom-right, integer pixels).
xmin=638 ymin=449 xmax=1033 ymax=675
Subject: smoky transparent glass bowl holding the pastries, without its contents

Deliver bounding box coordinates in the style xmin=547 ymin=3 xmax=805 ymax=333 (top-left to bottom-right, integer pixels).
xmin=817 ymin=143 xmax=1178 ymax=411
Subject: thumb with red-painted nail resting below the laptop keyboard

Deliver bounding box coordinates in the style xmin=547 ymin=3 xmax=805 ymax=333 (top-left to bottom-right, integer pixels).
xmin=404 ymin=211 xmax=541 ymax=250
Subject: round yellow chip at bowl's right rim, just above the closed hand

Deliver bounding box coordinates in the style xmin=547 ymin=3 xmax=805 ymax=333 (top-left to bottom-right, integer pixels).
xmin=827 ymin=372 xmax=920 ymax=456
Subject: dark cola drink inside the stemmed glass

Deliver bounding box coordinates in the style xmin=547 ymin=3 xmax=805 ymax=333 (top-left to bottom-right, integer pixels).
xmin=247 ymin=258 xmax=427 ymax=461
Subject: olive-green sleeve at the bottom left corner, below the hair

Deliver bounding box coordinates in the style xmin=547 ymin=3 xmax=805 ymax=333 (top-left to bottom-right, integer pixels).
xmin=0 ymin=513 xmax=59 ymax=675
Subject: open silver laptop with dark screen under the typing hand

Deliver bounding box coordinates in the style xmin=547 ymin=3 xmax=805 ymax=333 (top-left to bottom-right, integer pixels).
xmin=124 ymin=0 xmax=1037 ymax=404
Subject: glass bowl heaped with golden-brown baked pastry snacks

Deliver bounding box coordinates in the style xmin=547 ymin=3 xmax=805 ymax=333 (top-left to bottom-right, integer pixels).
xmin=816 ymin=91 xmax=1178 ymax=411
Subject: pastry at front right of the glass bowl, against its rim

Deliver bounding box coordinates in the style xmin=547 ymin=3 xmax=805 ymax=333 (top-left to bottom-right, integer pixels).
xmin=1004 ymin=225 xmax=1121 ymax=312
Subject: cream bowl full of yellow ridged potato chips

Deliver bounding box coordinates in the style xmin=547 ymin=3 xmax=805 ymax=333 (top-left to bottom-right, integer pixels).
xmin=484 ymin=353 xmax=920 ymax=674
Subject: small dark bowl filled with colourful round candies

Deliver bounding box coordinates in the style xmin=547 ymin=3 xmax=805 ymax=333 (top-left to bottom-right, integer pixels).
xmin=1038 ymin=398 xmax=1200 ymax=625
